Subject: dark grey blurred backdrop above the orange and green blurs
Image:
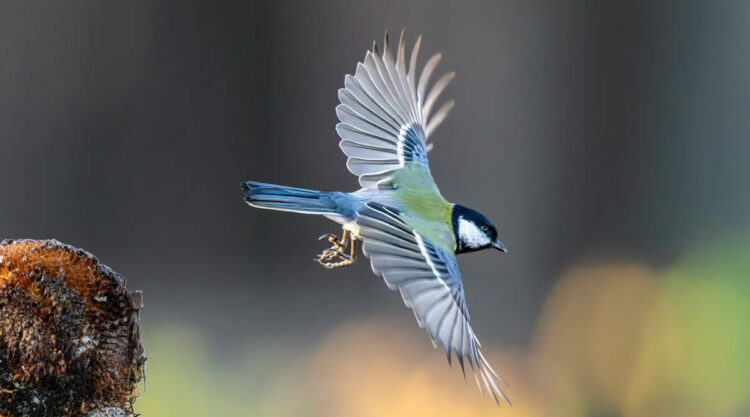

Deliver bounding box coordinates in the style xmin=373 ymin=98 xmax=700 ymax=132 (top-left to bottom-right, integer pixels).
xmin=0 ymin=1 xmax=750 ymax=352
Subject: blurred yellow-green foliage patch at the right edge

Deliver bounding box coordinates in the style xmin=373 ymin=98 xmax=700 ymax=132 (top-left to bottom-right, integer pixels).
xmin=625 ymin=239 xmax=750 ymax=417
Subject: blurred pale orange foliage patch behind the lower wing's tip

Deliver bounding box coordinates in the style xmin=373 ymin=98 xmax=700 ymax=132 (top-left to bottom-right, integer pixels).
xmin=309 ymin=320 xmax=540 ymax=417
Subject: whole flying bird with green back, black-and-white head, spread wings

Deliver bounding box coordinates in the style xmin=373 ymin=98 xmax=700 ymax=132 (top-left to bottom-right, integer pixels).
xmin=241 ymin=31 xmax=511 ymax=405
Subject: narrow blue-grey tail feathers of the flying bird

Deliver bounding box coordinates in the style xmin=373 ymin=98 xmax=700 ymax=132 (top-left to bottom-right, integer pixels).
xmin=240 ymin=181 xmax=337 ymax=214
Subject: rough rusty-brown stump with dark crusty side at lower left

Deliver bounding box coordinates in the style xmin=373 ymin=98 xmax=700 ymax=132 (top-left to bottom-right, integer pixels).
xmin=0 ymin=240 xmax=145 ymax=417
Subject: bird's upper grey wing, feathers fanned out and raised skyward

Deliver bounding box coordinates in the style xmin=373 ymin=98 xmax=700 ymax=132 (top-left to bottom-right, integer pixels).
xmin=336 ymin=32 xmax=454 ymax=188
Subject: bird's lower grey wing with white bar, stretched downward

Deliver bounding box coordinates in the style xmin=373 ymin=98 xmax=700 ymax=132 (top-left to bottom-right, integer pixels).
xmin=357 ymin=202 xmax=510 ymax=404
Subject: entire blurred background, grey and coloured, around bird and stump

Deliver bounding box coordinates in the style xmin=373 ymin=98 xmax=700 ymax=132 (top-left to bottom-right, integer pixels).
xmin=0 ymin=0 xmax=750 ymax=417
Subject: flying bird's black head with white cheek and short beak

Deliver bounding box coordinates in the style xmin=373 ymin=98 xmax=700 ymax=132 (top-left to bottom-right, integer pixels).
xmin=452 ymin=204 xmax=508 ymax=253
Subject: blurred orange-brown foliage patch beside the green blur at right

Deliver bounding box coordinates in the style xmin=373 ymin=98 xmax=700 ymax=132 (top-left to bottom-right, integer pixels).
xmin=535 ymin=264 xmax=655 ymax=416
